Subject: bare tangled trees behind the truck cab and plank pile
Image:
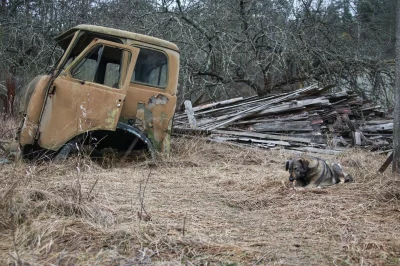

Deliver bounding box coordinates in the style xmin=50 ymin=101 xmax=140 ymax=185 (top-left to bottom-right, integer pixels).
xmin=0 ymin=0 xmax=397 ymax=112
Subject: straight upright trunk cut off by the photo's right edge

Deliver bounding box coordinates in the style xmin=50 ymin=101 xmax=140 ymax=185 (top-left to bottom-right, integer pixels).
xmin=392 ymin=1 xmax=400 ymax=174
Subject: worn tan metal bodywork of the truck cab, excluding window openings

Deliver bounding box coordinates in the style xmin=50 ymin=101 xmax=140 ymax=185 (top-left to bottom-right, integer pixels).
xmin=20 ymin=25 xmax=179 ymax=156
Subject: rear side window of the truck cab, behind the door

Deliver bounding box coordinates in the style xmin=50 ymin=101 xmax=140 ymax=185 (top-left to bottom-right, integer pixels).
xmin=131 ymin=47 xmax=168 ymax=88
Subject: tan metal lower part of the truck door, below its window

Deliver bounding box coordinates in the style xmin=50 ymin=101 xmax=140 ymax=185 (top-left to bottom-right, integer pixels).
xmin=38 ymin=77 xmax=125 ymax=150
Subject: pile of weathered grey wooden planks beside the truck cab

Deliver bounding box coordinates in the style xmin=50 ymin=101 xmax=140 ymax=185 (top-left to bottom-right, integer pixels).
xmin=174 ymin=85 xmax=393 ymax=154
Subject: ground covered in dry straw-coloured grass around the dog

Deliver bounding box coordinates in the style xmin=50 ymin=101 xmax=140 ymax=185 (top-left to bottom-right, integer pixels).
xmin=0 ymin=138 xmax=400 ymax=265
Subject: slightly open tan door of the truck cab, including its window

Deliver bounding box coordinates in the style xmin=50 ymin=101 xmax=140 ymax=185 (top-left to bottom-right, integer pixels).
xmin=38 ymin=39 xmax=139 ymax=150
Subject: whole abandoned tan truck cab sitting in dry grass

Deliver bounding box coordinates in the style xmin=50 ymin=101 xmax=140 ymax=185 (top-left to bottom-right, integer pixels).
xmin=18 ymin=25 xmax=179 ymax=158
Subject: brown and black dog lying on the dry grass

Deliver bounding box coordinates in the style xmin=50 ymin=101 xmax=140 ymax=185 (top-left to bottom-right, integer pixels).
xmin=286 ymin=155 xmax=353 ymax=188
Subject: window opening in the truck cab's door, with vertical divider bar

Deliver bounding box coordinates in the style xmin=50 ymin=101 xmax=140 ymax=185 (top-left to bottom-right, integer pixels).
xmin=71 ymin=45 xmax=123 ymax=88
